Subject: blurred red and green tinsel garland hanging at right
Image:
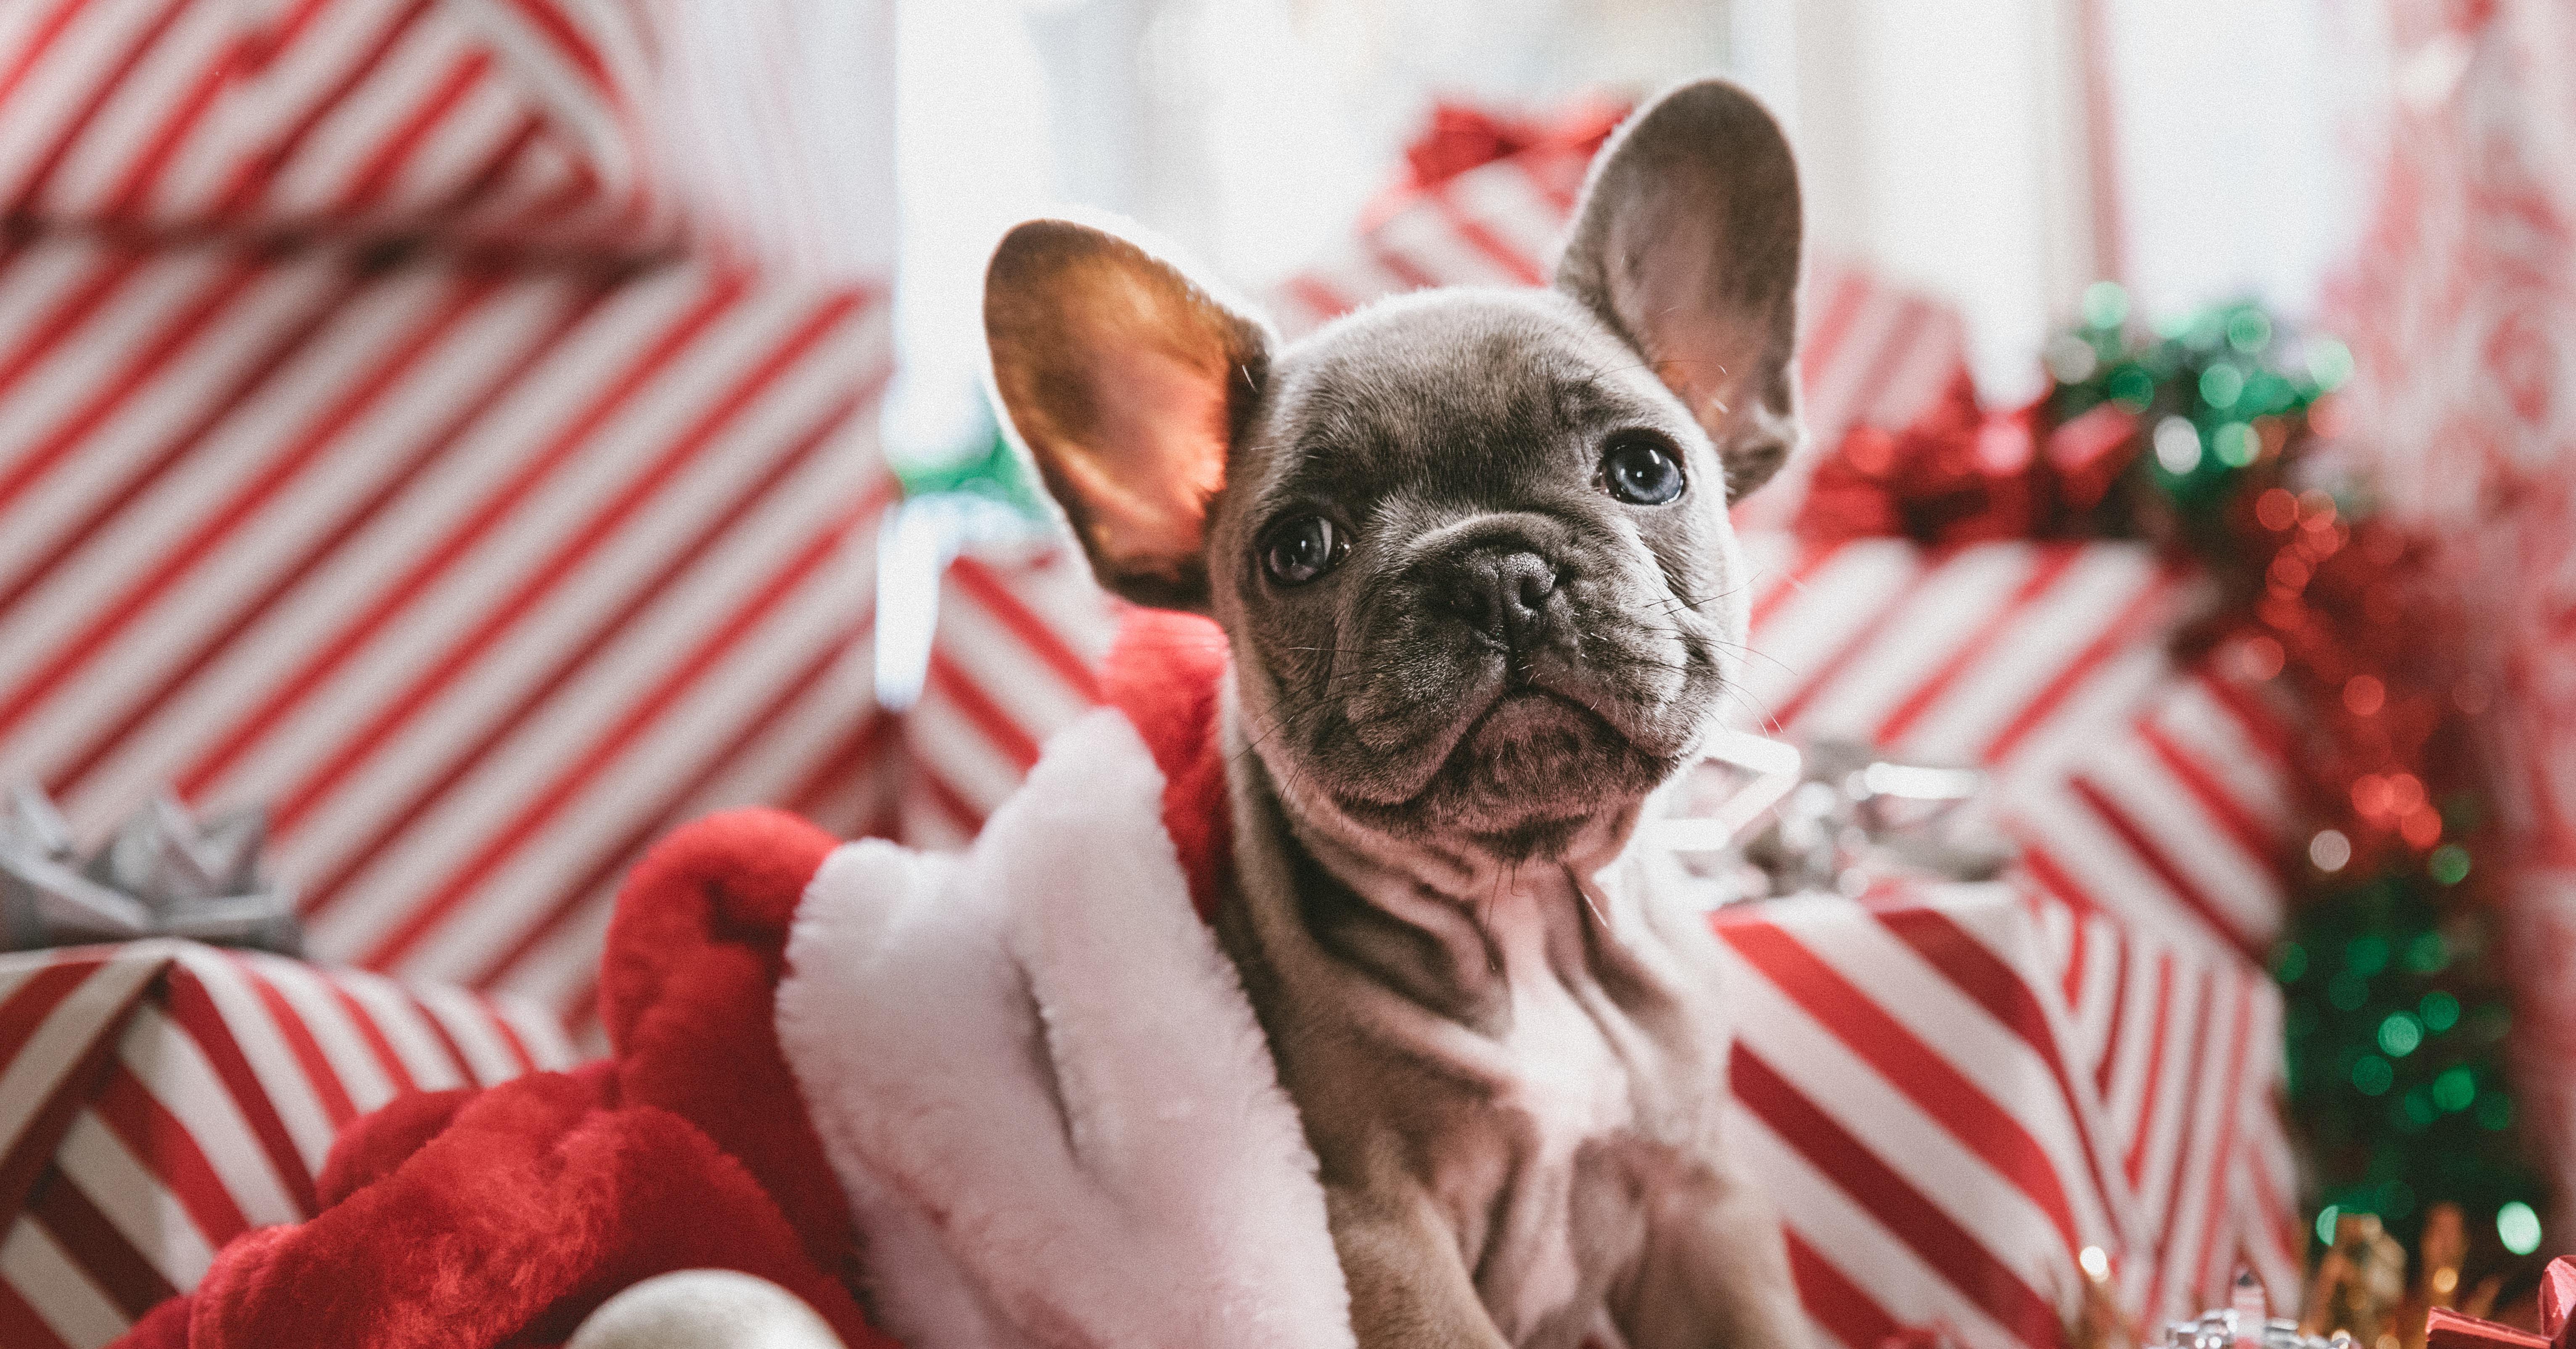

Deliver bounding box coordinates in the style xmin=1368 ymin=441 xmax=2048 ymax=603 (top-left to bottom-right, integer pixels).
xmin=2040 ymin=283 xmax=2565 ymax=1277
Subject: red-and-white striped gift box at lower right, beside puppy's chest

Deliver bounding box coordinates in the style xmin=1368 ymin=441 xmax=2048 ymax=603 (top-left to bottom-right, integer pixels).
xmin=1716 ymin=886 xmax=2298 ymax=1349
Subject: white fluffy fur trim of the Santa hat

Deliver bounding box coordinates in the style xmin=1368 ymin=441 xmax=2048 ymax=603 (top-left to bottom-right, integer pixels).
xmin=778 ymin=713 xmax=1353 ymax=1349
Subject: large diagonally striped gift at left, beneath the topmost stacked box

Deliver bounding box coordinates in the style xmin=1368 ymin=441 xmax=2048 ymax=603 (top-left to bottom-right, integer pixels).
xmin=0 ymin=239 xmax=891 ymax=1035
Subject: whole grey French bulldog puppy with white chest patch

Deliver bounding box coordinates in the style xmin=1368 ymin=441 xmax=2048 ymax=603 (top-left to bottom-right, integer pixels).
xmin=984 ymin=82 xmax=1806 ymax=1349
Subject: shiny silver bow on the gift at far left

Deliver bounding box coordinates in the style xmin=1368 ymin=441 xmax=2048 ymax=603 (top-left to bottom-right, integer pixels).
xmin=0 ymin=785 xmax=301 ymax=955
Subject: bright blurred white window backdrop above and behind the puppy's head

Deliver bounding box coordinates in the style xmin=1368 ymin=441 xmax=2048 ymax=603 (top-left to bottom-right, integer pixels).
xmin=896 ymin=0 xmax=2396 ymax=458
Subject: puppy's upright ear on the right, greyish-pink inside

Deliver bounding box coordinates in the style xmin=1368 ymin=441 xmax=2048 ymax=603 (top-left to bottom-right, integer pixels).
xmin=1556 ymin=80 xmax=1798 ymax=500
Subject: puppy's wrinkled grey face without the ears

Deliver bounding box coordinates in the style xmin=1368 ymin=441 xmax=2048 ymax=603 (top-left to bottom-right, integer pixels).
xmin=1208 ymin=291 xmax=1744 ymax=857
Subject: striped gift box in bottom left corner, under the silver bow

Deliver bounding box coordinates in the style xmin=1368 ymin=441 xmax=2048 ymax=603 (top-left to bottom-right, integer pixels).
xmin=0 ymin=940 xmax=572 ymax=1349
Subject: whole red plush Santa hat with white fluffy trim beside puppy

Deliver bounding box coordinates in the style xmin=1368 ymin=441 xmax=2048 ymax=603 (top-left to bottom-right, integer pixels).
xmin=126 ymin=613 xmax=1353 ymax=1349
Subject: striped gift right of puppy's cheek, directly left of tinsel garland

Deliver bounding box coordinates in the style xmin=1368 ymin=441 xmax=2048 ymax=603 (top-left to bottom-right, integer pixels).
xmin=1744 ymin=535 xmax=2290 ymax=952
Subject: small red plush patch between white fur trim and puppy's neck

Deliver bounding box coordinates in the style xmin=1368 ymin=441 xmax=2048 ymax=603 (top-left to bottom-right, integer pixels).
xmin=1100 ymin=610 xmax=1234 ymax=919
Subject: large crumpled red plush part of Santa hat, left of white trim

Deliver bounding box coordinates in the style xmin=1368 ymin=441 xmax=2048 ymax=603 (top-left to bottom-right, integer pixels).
xmin=121 ymin=811 xmax=891 ymax=1349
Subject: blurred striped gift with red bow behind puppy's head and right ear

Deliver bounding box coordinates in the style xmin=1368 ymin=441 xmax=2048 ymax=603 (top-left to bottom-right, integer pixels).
xmin=1270 ymin=132 xmax=1968 ymax=528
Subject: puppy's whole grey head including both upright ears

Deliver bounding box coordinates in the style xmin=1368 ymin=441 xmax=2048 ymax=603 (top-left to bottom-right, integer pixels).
xmin=984 ymin=80 xmax=1798 ymax=862
